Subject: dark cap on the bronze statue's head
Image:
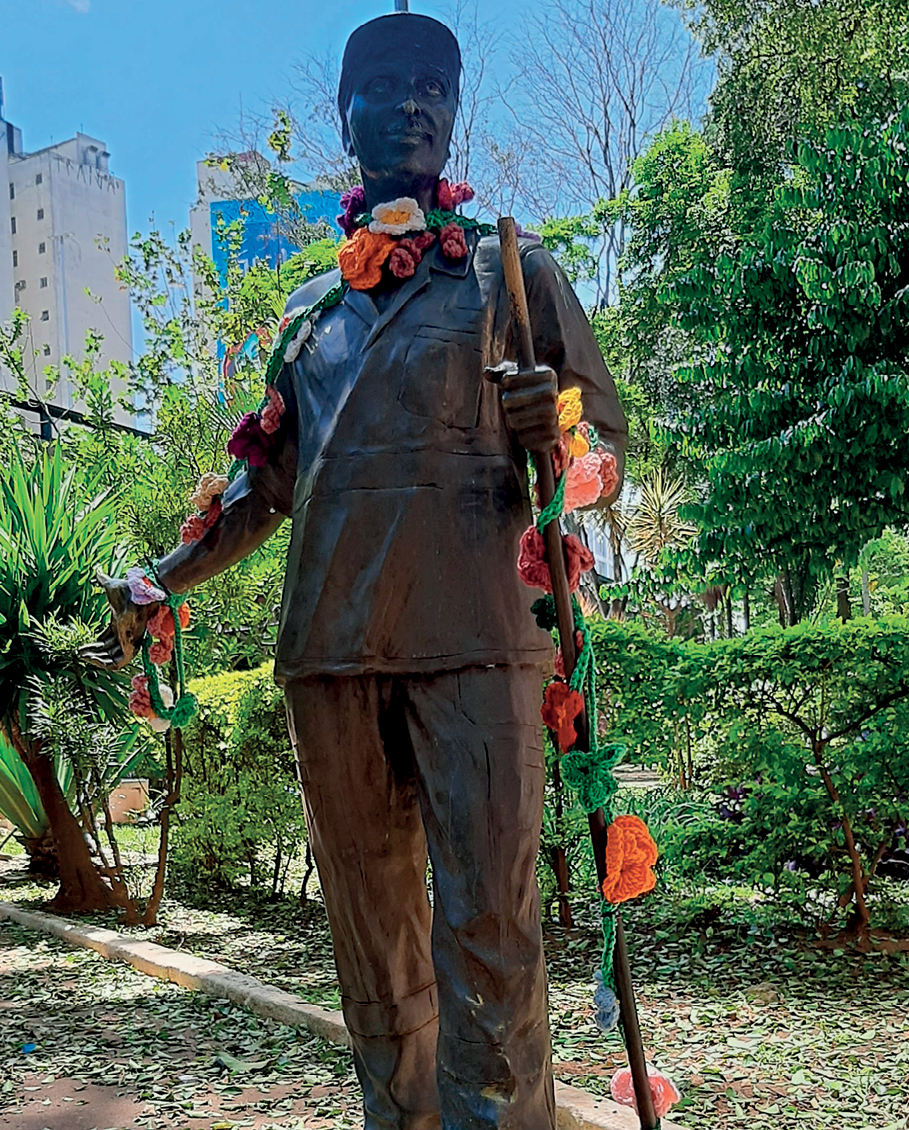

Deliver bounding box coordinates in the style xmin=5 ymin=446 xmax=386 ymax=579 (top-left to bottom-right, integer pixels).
xmin=338 ymin=11 xmax=461 ymax=118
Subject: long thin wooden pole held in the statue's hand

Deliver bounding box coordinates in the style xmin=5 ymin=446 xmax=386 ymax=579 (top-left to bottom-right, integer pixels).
xmin=497 ymin=216 xmax=657 ymax=1130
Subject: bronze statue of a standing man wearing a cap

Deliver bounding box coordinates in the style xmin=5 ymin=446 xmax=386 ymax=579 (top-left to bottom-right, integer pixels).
xmin=85 ymin=14 xmax=625 ymax=1130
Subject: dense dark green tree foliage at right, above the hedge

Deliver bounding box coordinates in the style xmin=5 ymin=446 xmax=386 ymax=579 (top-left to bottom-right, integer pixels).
xmin=672 ymin=107 xmax=909 ymax=601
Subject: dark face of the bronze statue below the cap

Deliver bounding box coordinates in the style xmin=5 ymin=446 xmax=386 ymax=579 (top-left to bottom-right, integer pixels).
xmin=344 ymin=58 xmax=458 ymax=179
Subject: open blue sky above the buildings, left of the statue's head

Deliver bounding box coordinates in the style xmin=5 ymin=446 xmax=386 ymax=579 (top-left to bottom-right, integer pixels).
xmin=0 ymin=0 xmax=504 ymax=232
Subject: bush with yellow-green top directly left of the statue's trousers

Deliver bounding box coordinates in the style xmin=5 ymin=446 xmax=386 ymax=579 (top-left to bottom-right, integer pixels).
xmin=172 ymin=663 xmax=305 ymax=894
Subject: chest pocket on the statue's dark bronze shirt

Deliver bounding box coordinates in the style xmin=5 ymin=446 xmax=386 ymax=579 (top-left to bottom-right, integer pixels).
xmin=398 ymin=327 xmax=484 ymax=428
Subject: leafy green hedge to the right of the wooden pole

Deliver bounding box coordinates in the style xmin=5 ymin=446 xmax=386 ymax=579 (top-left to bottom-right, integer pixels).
xmin=594 ymin=616 xmax=909 ymax=931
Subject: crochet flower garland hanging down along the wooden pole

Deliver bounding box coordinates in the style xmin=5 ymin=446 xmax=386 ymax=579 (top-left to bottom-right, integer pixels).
xmin=518 ymin=389 xmax=679 ymax=1118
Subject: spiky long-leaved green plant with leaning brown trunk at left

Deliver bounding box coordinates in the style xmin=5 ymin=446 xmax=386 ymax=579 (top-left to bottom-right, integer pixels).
xmin=0 ymin=445 xmax=131 ymax=910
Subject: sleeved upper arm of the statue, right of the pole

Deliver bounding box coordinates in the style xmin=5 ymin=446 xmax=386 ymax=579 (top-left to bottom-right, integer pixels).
xmin=521 ymin=244 xmax=627 ymax=505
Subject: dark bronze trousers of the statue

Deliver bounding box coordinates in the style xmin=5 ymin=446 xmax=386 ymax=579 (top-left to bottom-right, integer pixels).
xmin=285 ymin=666 xmax=555 ymax=1130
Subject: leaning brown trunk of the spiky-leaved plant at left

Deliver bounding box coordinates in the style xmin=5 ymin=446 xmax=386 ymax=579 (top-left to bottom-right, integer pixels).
xmin=10 ymin=723 xmax=123 ymax=912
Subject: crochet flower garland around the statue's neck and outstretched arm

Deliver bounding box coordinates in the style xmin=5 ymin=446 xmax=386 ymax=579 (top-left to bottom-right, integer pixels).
xmin=127 ymin=179 xmax=517 ymax=731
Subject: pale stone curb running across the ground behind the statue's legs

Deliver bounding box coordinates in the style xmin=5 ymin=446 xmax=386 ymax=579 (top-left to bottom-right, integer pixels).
xmin=0 ymin=902 xmax=683 ymax=1130
